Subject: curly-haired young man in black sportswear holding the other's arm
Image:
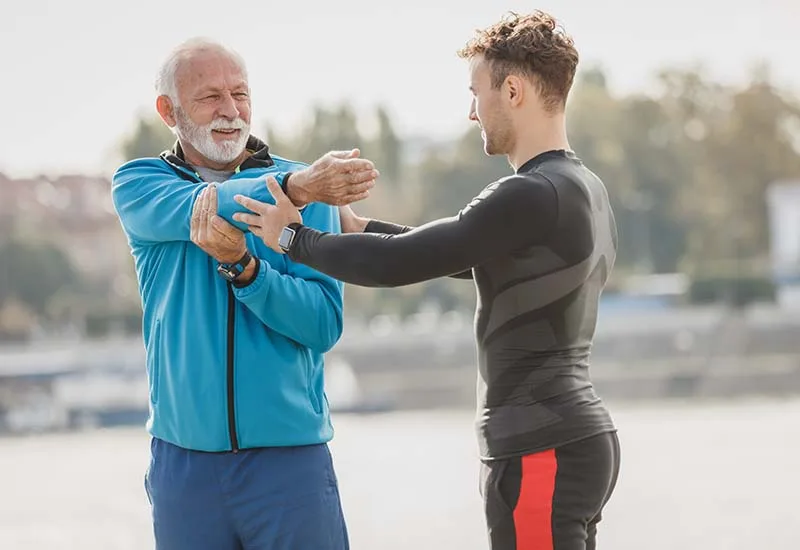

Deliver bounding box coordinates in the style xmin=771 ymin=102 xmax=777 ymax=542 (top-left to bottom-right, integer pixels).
xmin=234 ymin=11 xmax=619 ymax=550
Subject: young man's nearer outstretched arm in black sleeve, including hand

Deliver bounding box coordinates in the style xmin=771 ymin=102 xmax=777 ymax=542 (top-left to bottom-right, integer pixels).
xmin=237 ymin=176 xmax=557 ymax=287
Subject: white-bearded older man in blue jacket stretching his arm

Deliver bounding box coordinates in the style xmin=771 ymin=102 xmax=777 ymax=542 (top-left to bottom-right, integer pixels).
xmin=112 ymin=36 xmax=378 ymax=550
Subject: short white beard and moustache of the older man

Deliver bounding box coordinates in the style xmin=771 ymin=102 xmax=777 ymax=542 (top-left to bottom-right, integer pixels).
xmin=174 ymin=107 xmax=250 ymax=164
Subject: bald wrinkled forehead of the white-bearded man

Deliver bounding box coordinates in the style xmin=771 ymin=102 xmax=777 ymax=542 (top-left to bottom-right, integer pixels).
xmin=175 ymin=48 xmax=247 ymax=95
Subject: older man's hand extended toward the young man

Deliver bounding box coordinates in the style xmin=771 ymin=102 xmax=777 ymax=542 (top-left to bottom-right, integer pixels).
xmin=286 ymin=149 xmax=380 ymax=208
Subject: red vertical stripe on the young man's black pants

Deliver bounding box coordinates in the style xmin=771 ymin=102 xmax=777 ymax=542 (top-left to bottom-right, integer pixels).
xmin=514 ymin=449 xmax=558 ymax=550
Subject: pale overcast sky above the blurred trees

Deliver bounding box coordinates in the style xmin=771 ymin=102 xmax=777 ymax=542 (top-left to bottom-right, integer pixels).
xmin=0 ymin=0 xmax=800 ymax=177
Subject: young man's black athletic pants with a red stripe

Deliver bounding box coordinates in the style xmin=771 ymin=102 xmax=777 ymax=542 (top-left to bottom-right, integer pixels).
xmin=481 ymin=433 xmax=619 ymax=550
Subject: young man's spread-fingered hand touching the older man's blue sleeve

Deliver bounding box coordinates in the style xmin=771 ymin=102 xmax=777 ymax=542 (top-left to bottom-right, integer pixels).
xmin=233 ymin=176 xmax=303 ymax=254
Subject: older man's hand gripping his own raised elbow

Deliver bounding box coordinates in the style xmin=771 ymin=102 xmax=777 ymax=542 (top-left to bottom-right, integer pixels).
xmin=190 ymin=184 xmax=247 ymax=264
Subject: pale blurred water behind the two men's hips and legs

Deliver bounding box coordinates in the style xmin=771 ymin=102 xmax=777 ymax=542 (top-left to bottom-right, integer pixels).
xmin=0 ymin=399 xmax=800 ymax=550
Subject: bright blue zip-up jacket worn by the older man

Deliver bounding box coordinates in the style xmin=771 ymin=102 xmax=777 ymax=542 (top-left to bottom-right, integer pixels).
xmin=112 ymin=137 xmax=343 ymax=451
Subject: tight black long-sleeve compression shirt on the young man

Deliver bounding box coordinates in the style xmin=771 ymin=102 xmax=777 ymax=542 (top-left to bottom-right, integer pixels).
xmin=288 ymin=151 xmax=617 ymax=460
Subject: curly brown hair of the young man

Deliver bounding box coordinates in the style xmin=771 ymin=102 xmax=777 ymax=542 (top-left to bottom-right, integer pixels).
xmin=458 ymin=10 xmax=578 ymax=111
